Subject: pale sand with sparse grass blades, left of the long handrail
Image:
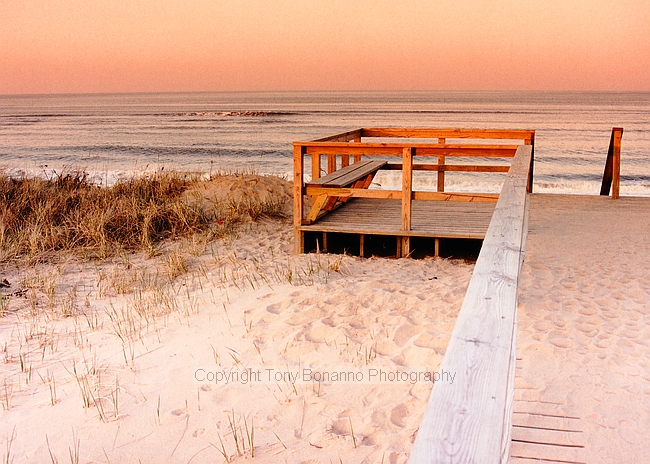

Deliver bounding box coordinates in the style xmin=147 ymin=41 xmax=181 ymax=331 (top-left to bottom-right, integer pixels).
xmin=0 ymin=176 xmax=470 ymax=463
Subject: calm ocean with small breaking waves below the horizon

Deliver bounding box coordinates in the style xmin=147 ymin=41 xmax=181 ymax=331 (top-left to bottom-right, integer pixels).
xmin=0 ymin=91 xmax=650 ymax=196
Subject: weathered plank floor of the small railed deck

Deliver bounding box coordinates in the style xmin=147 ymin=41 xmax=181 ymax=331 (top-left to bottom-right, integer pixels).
xmin=300 ymin=198 xmax=495 ymax=240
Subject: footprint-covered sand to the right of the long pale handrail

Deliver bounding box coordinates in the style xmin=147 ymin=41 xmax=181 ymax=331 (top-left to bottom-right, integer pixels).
xmin=513 ymin=196 xmax=650 ymax=463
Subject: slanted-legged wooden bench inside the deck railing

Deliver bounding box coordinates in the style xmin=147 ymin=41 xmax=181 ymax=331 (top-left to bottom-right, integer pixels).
xmin=306 ymin=160 xmax=387 ymax=224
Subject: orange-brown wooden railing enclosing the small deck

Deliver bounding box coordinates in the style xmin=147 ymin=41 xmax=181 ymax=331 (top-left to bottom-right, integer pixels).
xmin=293 ymin=128 xmax=535 ymax=256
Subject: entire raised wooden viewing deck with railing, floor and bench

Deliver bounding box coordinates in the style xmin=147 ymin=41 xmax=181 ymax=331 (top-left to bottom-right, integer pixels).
xmin=293 ymin=128 xmax=535 ymax=257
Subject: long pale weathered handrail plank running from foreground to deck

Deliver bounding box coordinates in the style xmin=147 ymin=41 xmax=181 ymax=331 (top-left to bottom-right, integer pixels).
xmin=410 ymin=145 xmax=532 ymax=464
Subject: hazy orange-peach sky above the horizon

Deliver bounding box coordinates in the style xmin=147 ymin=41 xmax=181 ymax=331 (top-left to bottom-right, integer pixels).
xmin=0 ymin=0 xmax=650 ymax=94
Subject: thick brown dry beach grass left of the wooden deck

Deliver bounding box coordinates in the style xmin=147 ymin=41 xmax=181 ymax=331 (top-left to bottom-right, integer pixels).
xmin=0 ymin=171 xmax=285 ymax=263
